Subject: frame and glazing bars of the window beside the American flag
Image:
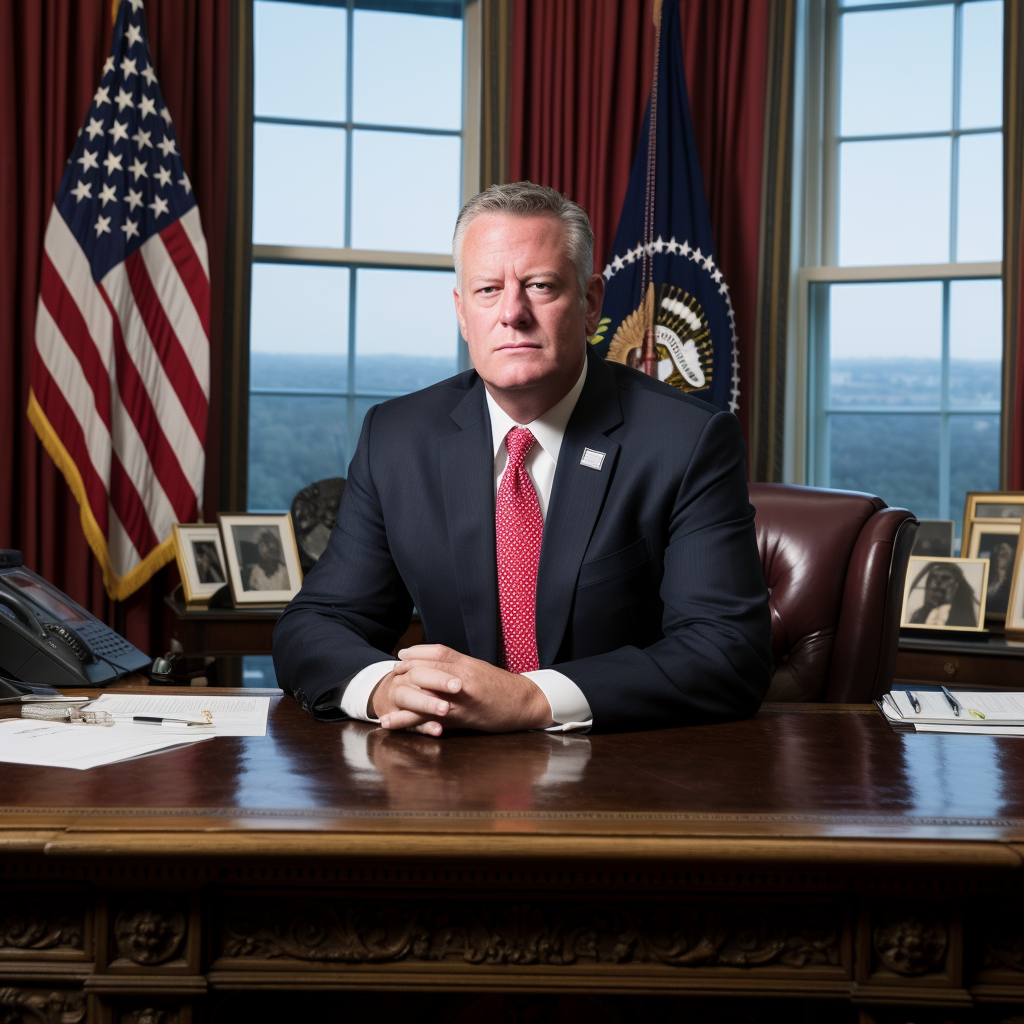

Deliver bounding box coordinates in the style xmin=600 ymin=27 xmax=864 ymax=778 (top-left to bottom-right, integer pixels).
xmin=241 ymin=0 xmax=482 ymax=512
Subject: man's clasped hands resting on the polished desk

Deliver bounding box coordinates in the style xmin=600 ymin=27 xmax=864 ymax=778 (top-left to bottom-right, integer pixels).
xmin=367 ymin=644 xmax=554 ymax=736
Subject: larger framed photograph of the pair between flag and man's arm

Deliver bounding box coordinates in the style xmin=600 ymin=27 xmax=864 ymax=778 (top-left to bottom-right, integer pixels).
xmin=217 ymin=512 xmax=302 ymax=605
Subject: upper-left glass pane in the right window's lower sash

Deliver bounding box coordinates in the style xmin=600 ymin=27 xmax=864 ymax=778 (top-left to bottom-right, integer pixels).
xmin=828 ymin=281 xmax=942 ymax=409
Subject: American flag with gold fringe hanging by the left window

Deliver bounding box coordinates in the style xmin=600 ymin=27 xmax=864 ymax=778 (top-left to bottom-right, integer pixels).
xmin=29 ymin=0 xmax=210 ymax=600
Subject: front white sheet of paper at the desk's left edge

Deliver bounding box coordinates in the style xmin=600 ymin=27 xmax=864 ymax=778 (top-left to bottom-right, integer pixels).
xmin=0 ymin=718 xmax=212 ymax=769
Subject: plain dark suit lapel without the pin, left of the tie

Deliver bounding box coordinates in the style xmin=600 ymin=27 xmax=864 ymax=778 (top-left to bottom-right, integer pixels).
xmin=439 ymin=378 xmax=499 ymax=665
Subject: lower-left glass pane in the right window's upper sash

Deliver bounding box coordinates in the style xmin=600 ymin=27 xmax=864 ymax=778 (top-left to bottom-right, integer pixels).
xmin=839 ymin=140 xmax=950 ymax=266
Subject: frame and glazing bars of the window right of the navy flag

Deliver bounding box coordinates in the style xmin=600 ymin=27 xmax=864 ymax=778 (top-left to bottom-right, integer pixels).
xmin=787 ymin=0 xmax=1007 ymax=509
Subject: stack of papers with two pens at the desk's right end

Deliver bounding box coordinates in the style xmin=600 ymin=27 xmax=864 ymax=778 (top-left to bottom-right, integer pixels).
xmin=879 ymin=687 xmax=1024 ymax=737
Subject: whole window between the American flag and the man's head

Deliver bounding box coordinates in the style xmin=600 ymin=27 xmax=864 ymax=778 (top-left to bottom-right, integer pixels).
xmin=248 ymin=0 xmax=466 ymax=511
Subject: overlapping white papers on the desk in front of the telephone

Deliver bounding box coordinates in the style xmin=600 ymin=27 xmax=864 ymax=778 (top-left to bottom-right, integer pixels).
xmin=0 ymin=691 xmax=270 ymax=769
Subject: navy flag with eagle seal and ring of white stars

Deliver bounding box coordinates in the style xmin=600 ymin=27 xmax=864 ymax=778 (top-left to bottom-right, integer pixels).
xmin=590 ymin=0 xmax=739 ymax=413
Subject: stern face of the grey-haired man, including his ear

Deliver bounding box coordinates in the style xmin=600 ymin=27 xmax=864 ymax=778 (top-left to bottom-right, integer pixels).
xmin=455 ymin=213 xmax=604 ymax=389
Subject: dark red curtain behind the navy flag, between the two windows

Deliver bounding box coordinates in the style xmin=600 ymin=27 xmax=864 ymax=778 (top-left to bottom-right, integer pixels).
xmin=509 ymin=0 xmax=768 ymax=446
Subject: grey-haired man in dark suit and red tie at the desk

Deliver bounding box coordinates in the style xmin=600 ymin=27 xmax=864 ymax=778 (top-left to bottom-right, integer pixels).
xmin=273 ymin=182 xmax=771 ymax=735
